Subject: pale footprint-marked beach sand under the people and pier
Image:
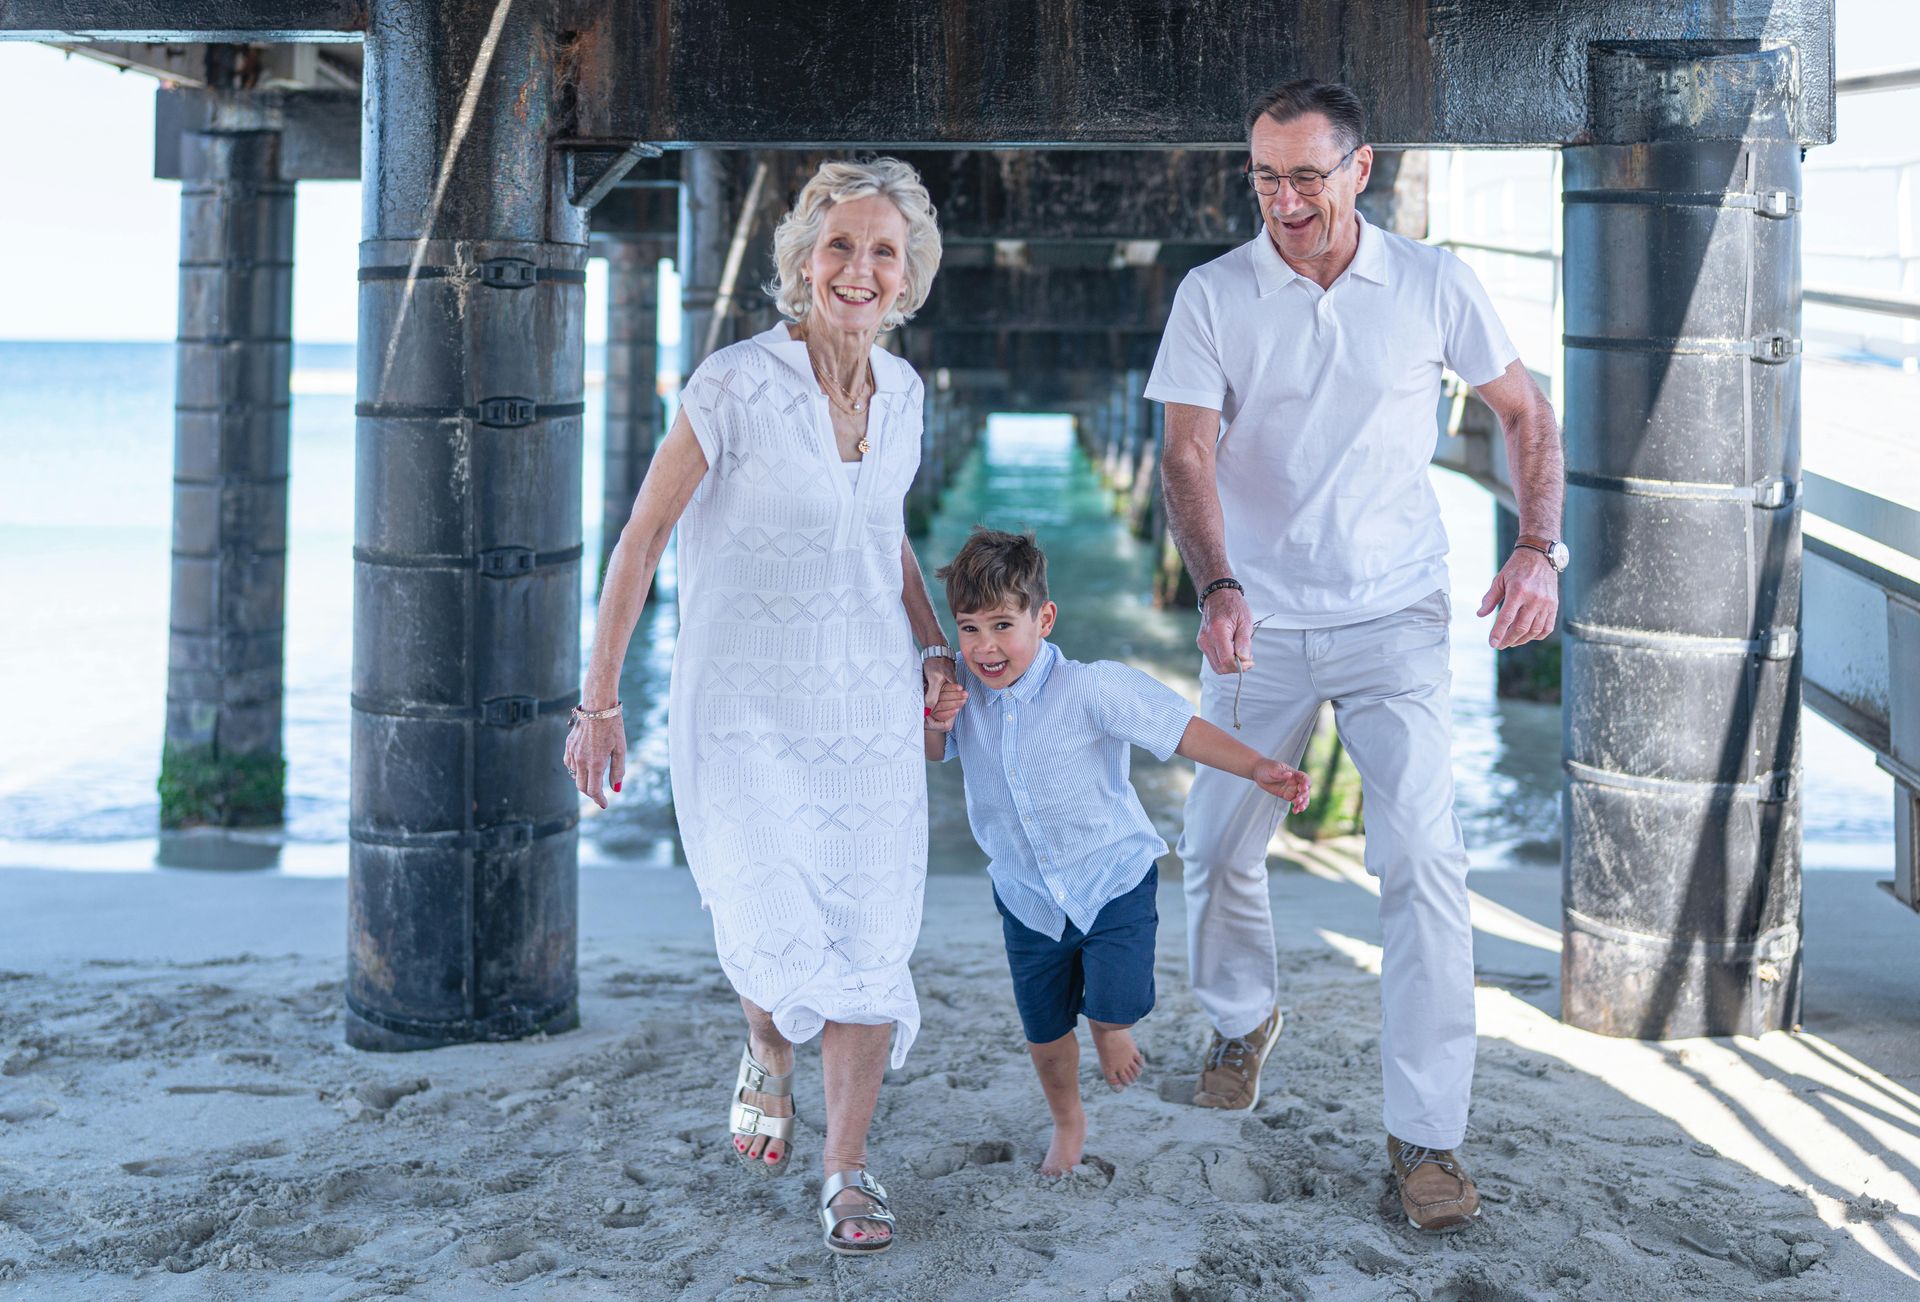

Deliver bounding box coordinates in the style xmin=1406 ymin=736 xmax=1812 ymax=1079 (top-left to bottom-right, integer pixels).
xmin=0 ymin=847 xmax=1920 ymax=1302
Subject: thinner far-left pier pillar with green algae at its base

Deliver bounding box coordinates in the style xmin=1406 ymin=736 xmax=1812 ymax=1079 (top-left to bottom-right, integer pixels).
xmin=159 ymin=131 xmax=294 ymax=828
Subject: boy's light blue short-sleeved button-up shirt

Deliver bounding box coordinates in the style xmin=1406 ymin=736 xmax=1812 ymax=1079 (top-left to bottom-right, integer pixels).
xmin=945 ymin=641 xmax=1194 ymax=941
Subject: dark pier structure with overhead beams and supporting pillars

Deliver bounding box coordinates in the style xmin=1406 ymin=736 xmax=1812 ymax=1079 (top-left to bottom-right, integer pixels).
xmin=0 ymin=0 xmax=1843 ymax=1049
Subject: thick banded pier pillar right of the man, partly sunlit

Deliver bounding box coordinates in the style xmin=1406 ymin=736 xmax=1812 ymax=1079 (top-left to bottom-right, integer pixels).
xmin=1563 ymin=42 xmax=1801 ymax=1039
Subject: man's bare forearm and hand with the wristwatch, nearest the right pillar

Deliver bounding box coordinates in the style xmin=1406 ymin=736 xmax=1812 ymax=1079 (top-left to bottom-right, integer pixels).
xmin=1475 ymin=361 xmax=1567 ymax=649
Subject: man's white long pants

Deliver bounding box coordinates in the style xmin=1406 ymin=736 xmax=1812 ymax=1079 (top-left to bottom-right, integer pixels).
xmin=1179 ymin=591 xmax=1475 ymax=1148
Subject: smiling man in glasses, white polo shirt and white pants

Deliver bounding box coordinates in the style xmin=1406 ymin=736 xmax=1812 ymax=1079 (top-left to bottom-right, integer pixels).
xmin=1146 ymin=81 xmax=1567 ymax=1229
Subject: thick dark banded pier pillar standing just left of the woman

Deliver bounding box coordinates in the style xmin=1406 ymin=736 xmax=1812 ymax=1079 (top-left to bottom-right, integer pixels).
xmin=346 ymin=0 xmax=586 ymax=1050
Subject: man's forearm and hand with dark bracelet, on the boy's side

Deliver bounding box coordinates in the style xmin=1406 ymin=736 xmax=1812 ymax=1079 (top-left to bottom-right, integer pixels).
xmin=1160 ymin=403 xmax=1254 ymax=674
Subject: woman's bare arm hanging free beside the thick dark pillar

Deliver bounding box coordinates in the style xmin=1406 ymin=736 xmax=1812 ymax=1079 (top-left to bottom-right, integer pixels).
xmin=566 ymin=411 xmax=707 ymax=808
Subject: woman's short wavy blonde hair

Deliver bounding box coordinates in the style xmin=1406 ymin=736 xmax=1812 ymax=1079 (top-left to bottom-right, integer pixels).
xmin=766 ymin=157 xmax=941 ymax=330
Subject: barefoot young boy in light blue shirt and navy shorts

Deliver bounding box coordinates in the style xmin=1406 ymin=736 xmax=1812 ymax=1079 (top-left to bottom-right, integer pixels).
xmin=925 ymin=528 xmax=1308 ymax=1175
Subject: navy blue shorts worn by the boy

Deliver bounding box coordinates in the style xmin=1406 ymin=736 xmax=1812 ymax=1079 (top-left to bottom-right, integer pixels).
xmin=993 ymin=864 xmax=1160 ymax=1045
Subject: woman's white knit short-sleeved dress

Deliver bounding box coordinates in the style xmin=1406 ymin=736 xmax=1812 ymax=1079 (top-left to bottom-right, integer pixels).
xmin=668 ymin=325 xmax=927 ymax=1066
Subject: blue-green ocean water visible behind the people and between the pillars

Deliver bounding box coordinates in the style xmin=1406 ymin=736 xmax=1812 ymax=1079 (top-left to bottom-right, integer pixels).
xmin=0 ymin=342 xmax=1893 ymax=872
